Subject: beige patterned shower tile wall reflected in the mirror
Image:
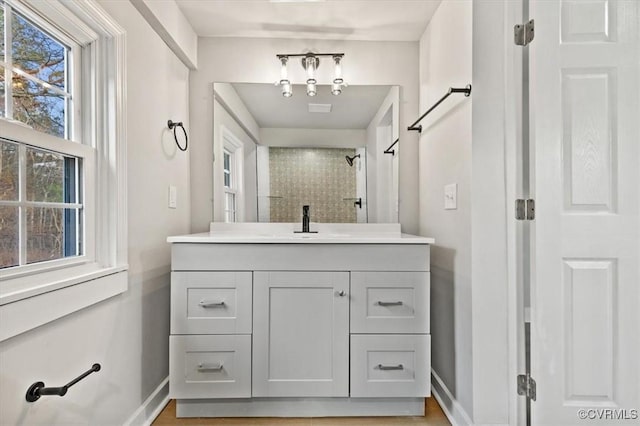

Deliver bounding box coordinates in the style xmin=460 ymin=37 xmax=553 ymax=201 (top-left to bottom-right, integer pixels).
xmin=269 ymin=147 xmax=359 ymax=223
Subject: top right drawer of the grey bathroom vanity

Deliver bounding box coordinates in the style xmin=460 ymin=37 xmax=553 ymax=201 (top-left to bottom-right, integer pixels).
xmin=351 ymin=272 xmax=429 ymax=333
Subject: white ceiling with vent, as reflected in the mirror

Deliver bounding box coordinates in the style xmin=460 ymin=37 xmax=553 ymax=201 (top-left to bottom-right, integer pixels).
xmin=232 ymin=83 xmax=391 ymax=129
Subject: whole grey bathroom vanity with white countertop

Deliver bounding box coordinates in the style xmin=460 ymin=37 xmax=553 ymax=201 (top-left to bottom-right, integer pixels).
xmin=168 ymin=223 xmax=433 ymax=417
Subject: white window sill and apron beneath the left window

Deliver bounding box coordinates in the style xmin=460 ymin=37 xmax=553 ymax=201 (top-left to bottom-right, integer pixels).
xmin=0 ymin=264 xmax=127 ymax=342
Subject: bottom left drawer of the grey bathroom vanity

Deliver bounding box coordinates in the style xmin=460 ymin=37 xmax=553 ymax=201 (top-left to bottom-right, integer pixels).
xmin=169 ymin=335 xmax=251 ymax=398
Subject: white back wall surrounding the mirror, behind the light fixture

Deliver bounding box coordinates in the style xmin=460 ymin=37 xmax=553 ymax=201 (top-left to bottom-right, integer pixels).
xmin=190 ymin=38 xmax=418 ymax=233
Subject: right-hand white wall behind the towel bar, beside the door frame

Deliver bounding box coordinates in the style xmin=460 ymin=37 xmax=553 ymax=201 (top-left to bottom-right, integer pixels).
xmin=420 ymin=1 xmax=474 ymax=422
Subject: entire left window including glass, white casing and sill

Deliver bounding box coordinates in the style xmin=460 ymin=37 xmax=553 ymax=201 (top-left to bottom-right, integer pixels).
xmin=0 ymin=0 xmax=127 ymax=341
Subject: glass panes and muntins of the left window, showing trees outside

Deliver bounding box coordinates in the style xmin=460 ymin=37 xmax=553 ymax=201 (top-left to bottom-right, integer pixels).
xmin=0 ymin=2 xmax=89 ymax=268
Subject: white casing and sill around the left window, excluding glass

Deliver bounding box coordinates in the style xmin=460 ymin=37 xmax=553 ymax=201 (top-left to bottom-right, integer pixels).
xmin=0 ymin=0 xmax=128 ymax=341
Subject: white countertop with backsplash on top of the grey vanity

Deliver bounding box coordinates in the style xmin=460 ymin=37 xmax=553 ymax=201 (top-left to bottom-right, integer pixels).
xmin=167 ymin=223 xmax=435 ymax=244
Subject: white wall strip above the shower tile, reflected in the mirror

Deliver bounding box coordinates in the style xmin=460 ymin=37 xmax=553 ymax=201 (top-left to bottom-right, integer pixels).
xmin=260 ymin=128 xmax=367 ymax=148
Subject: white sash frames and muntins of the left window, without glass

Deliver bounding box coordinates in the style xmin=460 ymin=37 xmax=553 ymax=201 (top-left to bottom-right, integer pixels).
xmin=0 ymin=0 xmax=92 ymax=276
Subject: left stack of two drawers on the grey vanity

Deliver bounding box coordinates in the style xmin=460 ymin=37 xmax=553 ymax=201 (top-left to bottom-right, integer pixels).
xmin=169 ymin=271 xmax=253 ymax=398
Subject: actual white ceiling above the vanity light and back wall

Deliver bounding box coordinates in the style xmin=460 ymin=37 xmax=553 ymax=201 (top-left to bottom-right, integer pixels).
xmin=176 ymin=0 xmax=442 ymax=41
